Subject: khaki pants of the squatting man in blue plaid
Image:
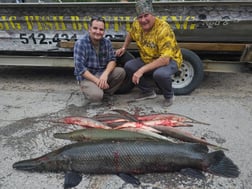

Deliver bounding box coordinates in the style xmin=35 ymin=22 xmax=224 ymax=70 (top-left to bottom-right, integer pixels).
xmin=80 ymin=67 xmax=126 ymax=102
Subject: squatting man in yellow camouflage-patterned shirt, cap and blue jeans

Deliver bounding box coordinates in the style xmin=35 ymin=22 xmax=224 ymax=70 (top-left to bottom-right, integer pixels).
xmin=116 ymin=0 xmax=182 ymax=106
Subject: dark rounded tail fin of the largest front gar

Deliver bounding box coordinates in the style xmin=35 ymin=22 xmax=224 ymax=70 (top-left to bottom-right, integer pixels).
xmin=206 ymin=150 xmax=240 ymax=178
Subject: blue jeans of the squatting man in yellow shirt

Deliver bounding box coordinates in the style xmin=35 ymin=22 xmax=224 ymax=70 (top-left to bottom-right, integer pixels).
xmin=124 ymin=57 xmax=178 ymax=98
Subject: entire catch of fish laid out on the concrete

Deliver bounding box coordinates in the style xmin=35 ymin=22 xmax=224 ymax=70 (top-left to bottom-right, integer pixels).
xmin=13 ymin=110 xmax=240 ymax=188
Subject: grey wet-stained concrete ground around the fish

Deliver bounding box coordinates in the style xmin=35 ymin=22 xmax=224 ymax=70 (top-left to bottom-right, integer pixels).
xmin=0 ymin=67 xmax=252 ymax=189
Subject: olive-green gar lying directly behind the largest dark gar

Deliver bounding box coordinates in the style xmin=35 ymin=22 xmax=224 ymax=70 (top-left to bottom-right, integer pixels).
xmin=53 ymin=128 xmax=159 ymax=142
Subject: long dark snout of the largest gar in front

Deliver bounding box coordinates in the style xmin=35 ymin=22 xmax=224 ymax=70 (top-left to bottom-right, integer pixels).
xmin=12 ymin=160 xmax=42 ymax=171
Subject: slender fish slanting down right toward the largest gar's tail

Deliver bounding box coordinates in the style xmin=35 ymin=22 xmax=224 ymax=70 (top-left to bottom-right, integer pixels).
xmin=150 ymin=125 xmax=228 ymax=150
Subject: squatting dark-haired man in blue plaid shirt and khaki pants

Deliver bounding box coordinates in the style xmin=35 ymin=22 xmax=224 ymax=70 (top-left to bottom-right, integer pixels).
xmin=74 ymin=17 xmax=126 ymax=102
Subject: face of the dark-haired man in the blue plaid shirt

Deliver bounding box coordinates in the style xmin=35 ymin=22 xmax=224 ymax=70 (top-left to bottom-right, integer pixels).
xmin=89 ymin=20 xmax=105 ymax=41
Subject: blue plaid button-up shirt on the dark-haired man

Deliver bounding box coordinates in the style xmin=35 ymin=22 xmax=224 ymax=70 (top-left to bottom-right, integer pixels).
xmin=74 ymin=34 xmax=116 ymax=81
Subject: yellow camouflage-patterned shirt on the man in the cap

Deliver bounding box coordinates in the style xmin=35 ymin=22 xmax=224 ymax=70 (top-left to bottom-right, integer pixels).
xmin=129 ymin=18 xmax=183 ymax=67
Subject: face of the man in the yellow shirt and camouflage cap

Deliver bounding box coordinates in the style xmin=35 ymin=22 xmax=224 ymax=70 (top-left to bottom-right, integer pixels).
xmin=137 ymin=13 xmax=155 ymax=32
